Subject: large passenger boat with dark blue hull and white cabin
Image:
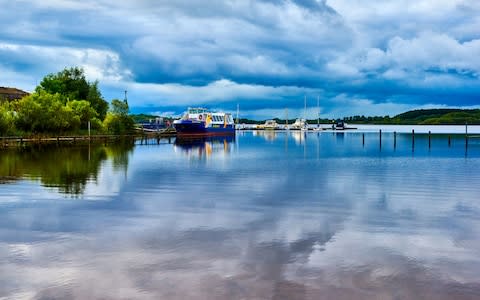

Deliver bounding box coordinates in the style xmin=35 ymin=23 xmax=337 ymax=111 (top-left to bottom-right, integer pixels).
xmin=173 ymin=108 xmax=235 ymax=137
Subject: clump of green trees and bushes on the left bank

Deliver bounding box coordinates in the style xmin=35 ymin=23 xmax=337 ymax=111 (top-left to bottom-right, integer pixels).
xmin=0 ymin=67 xmax=134 ymax=136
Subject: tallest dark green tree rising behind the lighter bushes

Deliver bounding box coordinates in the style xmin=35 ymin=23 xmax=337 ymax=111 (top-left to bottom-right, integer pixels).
xmin=36 ymin=67 xmax=108 ymax=120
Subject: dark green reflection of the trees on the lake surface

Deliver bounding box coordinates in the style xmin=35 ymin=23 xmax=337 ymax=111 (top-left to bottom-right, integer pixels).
xmin=0 ymin=141 xmax=134 ymax=195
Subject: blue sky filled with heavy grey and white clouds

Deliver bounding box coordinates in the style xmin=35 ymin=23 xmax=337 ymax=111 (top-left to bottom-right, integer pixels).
xmin=0 ymin=0 xmax=480 ymax=119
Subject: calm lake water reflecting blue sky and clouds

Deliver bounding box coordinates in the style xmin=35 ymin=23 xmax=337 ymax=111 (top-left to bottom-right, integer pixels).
xmin=0 ymin=132 xmax=480 ymax=299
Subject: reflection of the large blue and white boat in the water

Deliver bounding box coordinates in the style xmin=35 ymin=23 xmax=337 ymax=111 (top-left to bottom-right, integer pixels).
xmin=174 ymin=136 xmax=235 ymax=160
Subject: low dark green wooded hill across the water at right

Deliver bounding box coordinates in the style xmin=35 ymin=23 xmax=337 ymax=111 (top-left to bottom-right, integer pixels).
xmin=344 ymin=108 xmax=480 ymax=125
